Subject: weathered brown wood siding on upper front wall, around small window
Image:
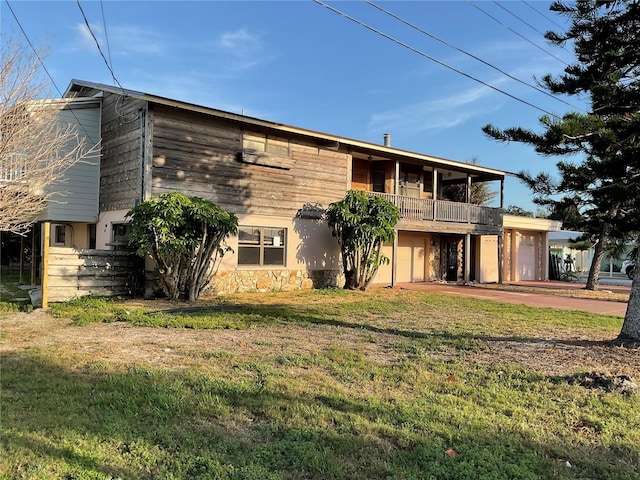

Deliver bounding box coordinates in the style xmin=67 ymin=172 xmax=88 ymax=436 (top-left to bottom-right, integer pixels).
xmin=152 ymin=105 xmax=349 ymax=217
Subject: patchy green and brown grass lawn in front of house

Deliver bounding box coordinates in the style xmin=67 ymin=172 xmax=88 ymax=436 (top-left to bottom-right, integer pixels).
xmin=0 ymin=288 xmax=640 ymax=480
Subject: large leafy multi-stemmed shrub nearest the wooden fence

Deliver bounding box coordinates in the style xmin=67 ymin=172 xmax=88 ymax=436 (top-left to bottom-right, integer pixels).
xmin=127 ymin=192 xmax=238 ymax=301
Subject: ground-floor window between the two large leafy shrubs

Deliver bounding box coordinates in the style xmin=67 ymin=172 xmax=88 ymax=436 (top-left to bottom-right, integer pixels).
xmin=238 ymin=227 xmax=287 ymax=266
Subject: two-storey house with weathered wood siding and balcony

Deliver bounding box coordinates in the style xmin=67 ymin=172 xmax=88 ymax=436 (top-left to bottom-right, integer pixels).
xmin=26 ymin=80 xmax=560 ymax=302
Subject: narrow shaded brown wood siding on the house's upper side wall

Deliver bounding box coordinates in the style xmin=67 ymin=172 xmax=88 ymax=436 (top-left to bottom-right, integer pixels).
xmin=100 ymin=93 xmax=146 ymax=211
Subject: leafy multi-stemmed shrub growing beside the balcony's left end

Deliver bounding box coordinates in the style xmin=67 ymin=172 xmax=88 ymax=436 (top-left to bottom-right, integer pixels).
xmin=326 ymin=190 xmax=400 ymax=290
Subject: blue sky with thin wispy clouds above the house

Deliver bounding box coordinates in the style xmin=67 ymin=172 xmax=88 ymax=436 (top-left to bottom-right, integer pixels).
xmin=0 ymin=0 xmax=584 ymax=211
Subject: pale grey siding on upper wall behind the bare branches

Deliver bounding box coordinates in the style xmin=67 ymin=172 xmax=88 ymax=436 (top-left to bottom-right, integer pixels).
xmin=38 ymin=100 xmax=100 ymax=222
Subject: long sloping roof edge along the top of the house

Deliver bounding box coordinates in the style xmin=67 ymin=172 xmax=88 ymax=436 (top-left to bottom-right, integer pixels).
xmin=64 ymin=79 xmax=506 ymax=180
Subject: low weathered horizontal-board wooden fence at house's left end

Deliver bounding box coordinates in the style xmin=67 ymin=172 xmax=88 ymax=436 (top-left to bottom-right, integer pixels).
xmin=47 ymin=247 xmax=142 ymax=302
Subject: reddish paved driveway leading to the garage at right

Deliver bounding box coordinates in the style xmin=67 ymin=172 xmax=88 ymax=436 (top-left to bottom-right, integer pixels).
xmin=398 ymin=282 xmax=631 ymax=317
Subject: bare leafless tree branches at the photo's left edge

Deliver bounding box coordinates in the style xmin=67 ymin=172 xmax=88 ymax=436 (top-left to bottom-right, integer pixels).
xmin=0 ymin=35 xmax=95 ymax=233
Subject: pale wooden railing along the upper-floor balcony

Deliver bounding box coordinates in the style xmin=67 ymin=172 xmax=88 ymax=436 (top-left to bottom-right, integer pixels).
xmin=369 ymin=192 xmax=502 ymax=227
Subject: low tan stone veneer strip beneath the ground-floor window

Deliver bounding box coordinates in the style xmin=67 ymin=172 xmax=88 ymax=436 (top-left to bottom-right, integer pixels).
xmin=207 ymin=270 xmax=344 ymax=295
